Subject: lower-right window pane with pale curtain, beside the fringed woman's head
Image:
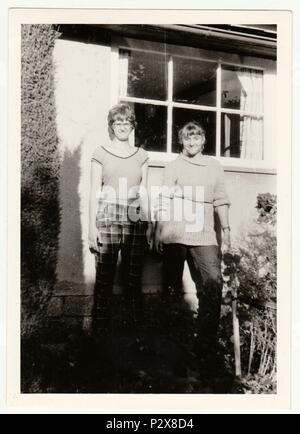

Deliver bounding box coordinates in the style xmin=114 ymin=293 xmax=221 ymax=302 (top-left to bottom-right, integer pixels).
xmin=221 ymin=113 xmax=263 ymax=160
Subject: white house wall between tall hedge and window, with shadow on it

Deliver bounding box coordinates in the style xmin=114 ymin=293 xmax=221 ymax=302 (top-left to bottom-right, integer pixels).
xmin=54 ymin=40 xmax=110 ymax=294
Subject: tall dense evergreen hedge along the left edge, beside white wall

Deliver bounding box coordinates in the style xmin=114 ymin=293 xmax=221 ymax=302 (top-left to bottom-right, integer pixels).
xmin=21 ymin=24 xmax=60 ymax=334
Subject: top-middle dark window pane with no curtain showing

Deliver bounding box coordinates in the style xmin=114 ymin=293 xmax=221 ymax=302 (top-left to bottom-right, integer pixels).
xmin=173 ymin=57 xmax=217 ymax=106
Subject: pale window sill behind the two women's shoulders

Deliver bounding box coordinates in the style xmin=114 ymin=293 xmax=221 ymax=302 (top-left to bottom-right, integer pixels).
xmin=148 ymin=152 xmax=277 ymax=175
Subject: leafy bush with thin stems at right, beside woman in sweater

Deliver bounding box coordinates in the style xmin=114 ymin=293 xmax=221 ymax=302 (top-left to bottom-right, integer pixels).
xmin=221 ymin=193 xmax=277 ymax=393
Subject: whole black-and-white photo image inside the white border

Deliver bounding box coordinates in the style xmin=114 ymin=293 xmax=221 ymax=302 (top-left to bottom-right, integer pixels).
xmin=14 ymin=16 xmax=286 ymax=395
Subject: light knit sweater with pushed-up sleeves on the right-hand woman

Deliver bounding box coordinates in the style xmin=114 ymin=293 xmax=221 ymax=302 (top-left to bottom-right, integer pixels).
xmin=157 ymin=154 xmax=230 ymax=246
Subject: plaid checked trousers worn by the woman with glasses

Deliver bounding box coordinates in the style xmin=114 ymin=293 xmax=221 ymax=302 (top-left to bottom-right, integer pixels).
xmin=93 ymin=203 xmax=146 ymax=328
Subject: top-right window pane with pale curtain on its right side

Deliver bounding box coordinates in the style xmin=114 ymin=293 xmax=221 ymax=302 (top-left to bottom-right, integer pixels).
xmin=222 ymin=66 xmax=263 ymax=113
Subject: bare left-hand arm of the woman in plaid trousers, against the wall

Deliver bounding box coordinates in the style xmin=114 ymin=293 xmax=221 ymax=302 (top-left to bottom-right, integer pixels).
xmin=89 ymin=160 xmax=102 ymax=253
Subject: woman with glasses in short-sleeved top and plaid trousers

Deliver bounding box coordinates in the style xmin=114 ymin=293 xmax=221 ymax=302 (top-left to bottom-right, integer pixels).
xmin=89 ymin=104 xmax=152 ymax=329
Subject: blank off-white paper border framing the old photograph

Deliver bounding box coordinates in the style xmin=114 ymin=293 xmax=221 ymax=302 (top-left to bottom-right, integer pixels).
xmin=7 ymin=9 xmax=292 ymax=413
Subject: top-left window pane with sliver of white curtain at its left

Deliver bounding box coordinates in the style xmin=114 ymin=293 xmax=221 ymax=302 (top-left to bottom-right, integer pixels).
xmin=119 ymin=50 xmax=168 ymax=101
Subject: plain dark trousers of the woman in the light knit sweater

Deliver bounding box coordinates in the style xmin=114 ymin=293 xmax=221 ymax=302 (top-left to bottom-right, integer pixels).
xmin=163 ymin=244 xmax=222 ymax=347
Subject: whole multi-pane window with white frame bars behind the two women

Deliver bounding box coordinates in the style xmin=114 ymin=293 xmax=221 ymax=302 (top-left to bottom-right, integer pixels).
xmin=119 ymin=49 xmax=264 ymax=160
